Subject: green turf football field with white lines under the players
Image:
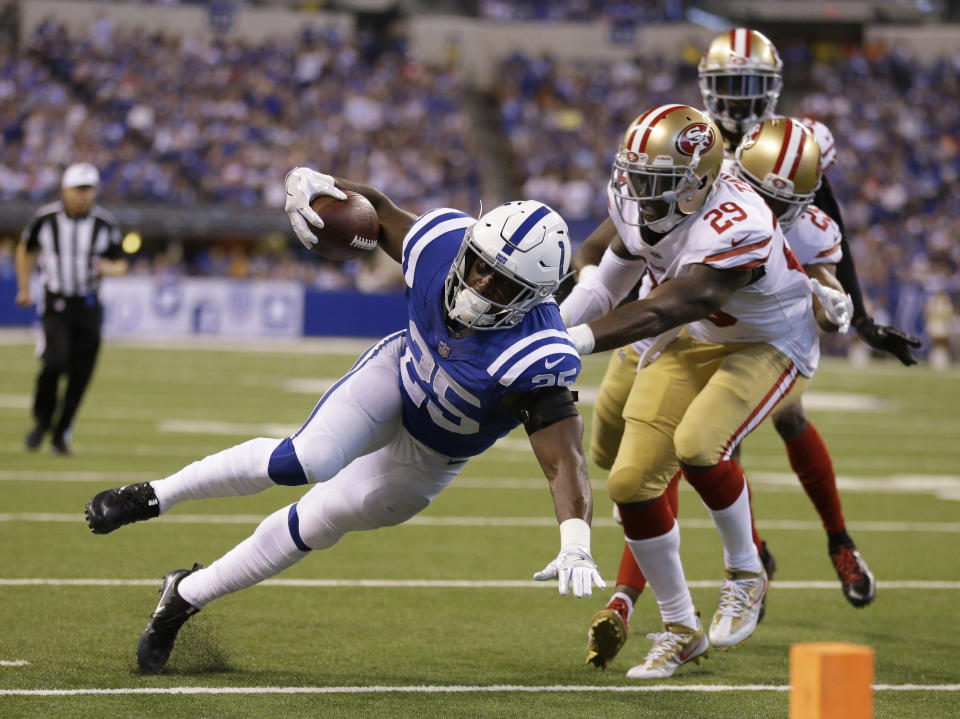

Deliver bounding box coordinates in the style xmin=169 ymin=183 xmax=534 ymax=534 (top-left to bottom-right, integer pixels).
xmin=0 ymin=335 xmax=960 ymax=719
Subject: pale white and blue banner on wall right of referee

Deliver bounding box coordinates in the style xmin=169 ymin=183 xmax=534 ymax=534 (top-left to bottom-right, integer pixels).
xmin=100 ymin=277 xmax=304 ymax=337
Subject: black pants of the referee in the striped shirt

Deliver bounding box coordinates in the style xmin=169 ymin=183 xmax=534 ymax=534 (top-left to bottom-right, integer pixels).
xmin=33 ymin=292 xmax=103 ymax=438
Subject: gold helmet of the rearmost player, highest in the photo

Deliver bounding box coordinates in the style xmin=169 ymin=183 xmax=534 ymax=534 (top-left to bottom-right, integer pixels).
xmin=698 ymin=27 xmax=783 ymax=136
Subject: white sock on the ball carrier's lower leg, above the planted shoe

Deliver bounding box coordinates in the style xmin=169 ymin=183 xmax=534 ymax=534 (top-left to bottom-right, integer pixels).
xmin=177 ymin=507 xmax=309 ymax=608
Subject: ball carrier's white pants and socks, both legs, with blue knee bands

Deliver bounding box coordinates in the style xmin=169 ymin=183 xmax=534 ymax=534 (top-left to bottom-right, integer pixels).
xmin=151 ymin=332 xmax=466 ymax=607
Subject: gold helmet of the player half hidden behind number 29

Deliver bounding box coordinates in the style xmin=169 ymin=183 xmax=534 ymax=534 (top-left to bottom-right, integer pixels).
xmin=733 ymin=117 xmax=822 ymax=230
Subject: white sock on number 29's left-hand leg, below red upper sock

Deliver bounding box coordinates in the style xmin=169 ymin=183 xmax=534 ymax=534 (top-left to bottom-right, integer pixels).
xmin=627 ymin=521 xmax=697 ymax=628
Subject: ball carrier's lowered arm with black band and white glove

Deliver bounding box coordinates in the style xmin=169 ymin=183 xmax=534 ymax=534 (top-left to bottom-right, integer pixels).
xmin=506 ymin=388 xmax=607 ymax=599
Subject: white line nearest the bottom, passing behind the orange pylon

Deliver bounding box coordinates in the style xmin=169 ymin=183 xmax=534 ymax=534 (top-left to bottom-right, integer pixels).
xmin=0 ymin=684 xmax=960 ymax=697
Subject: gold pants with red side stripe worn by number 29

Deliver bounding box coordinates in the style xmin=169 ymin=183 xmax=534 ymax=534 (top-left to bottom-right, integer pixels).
xmin=608 ymin=332 xmax=810 ymax=504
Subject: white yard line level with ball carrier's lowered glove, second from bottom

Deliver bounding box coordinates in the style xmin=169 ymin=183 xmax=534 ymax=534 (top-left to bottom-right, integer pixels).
xmin=0 ymin=577 xmax=960 ymax=592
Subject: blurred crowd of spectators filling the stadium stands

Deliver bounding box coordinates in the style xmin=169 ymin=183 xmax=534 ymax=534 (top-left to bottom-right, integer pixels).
xmin=0 ymin=16 xmax=960 ymax=344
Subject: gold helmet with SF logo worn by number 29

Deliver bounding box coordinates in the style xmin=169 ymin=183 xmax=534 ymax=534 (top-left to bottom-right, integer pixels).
xmin=610 ymin=105 xmax=723 ymax=233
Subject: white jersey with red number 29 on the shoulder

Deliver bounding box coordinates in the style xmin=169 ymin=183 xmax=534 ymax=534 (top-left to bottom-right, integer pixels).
xmin=608 ymin=173 xmax=820 ymax=377
